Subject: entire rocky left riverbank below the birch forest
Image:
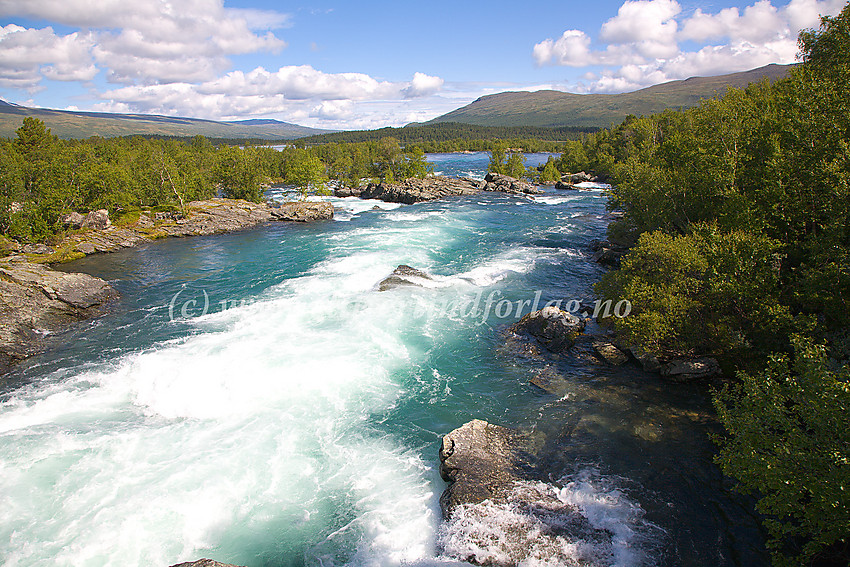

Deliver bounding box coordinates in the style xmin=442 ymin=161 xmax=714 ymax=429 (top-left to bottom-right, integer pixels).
xmin=0 ymin=199 xmax=334 ymax=374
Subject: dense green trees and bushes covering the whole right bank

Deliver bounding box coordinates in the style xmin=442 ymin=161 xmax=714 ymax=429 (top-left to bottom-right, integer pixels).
xmin=560 ymin=5 xmax=850 ymax=565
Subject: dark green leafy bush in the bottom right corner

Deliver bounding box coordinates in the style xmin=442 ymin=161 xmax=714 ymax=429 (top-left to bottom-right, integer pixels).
xmin=715 ymin=342 xmax=850 ymax=566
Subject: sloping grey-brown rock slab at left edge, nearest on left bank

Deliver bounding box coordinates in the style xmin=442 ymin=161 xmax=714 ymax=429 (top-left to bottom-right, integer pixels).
xmin=0 ymin=261 xmax=118 ymax=374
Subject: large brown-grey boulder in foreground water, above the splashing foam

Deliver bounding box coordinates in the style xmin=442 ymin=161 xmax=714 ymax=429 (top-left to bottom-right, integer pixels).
xmin=440 ymin=419 xmax=533 ymax=518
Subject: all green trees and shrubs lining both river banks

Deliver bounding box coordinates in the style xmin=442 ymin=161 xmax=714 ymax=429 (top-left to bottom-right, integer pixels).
xmin=0 ymin=4 xmax=850 ymax=566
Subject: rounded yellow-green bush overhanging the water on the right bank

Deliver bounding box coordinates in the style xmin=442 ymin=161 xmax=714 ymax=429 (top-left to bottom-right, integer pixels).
xmin=597 ymin=225 xmax=792 ymax=364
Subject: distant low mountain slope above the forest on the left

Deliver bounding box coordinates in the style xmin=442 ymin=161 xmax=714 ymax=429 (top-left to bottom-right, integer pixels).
xmin=0 ymin=101 xmax=331 ymax=140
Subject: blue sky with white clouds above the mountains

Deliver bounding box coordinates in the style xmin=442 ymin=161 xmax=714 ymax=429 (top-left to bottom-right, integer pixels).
xmin=0 ymin=0 xmax=844 ymax=129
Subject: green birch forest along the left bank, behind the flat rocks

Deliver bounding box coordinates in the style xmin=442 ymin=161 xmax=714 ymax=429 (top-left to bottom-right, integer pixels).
xmin=0 ymin=127 xmax=428 ymax=242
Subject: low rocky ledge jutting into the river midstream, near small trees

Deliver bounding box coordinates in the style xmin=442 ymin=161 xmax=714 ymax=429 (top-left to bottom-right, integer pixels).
xmin=334 ymin=173 xmax=540 ymax=205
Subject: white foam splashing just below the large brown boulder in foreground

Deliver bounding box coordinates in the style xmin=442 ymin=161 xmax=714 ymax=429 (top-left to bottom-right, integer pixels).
xmin=438 ymin=469 xmax=660 ymax=567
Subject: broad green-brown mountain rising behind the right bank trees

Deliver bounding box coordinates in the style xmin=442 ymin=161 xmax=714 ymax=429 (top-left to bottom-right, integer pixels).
xmin=426 ymin=65 xmax=793 ymax=128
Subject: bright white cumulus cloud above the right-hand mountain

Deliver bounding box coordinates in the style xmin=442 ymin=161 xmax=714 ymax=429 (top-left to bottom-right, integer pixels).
xmin=532 ymin=0 xmax=844 ymax=92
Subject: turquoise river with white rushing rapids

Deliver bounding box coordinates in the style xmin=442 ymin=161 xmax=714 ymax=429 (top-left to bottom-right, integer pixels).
xmin=0 ymin=154 xmax=764 ymax=566
